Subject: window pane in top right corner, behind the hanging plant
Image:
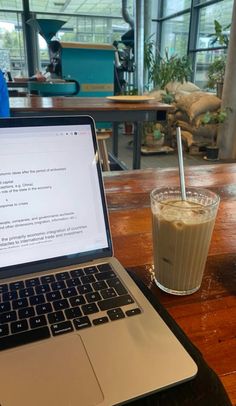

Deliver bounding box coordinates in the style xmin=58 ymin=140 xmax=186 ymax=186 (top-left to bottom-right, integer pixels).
xmin=197 ymin=0 xmax=233 ymax=48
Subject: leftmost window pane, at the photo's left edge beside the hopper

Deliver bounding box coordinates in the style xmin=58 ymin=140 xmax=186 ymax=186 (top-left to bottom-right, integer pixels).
xmin=0 ymin=12 xmax=27 ymax=78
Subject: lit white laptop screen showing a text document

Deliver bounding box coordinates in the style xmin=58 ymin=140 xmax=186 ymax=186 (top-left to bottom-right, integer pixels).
xmin=0 ymin=117 xmax=111 ymax=273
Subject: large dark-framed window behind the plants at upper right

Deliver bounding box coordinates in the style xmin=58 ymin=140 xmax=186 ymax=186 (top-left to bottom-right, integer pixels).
xmin=157 ymin=0 xmax=233 ymax=88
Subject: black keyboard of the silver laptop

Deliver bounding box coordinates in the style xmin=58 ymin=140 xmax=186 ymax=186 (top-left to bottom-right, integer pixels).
xmin=0 ymin=263 xmax=141 ymax=350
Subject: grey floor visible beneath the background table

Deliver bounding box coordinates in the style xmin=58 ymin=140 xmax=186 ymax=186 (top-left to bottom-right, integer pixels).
xmin=107 ymin=133 xmax=230 ymax=169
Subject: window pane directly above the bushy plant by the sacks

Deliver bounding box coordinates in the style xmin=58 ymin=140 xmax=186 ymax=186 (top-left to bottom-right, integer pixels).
xmin=161 ymin=13 xmax=190 ymax=56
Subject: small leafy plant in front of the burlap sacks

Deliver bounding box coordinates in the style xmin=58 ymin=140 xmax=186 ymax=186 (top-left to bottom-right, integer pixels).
xmin=201 ymin=109 xmax=229 ymax=161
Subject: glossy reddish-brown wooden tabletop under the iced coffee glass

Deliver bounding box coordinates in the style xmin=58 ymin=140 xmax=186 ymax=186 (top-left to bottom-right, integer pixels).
xmin=104 ymin=164 xmax=236 ymax=406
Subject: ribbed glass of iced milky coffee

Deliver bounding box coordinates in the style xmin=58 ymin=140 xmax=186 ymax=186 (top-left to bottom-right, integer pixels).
xmin=150 ymin=187 xmax=220 ymax=295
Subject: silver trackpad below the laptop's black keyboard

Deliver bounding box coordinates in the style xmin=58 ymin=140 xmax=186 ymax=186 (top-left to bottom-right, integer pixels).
xmin=0 ymin=334 xmax=104 ymax=406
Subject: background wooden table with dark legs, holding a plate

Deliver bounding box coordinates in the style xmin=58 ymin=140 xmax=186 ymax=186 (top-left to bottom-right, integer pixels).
xmin=10 ymin=96 xmax=171 ymax=169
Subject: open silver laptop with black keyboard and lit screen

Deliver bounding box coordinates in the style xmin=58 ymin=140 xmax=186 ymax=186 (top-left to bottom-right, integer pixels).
xmin=0 ymin=116 xmax=197 ymax=406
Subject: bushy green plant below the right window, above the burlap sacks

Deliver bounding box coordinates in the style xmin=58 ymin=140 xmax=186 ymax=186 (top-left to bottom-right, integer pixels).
xmin=144 ymin=38 xmax=192 ymax=89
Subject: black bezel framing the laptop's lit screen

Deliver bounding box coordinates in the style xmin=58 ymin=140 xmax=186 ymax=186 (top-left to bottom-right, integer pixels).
xmin=0 ymin=115 xmax=113 ymax=280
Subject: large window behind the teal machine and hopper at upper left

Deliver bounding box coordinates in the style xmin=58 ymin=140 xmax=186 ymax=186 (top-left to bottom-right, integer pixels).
xmin=0 ymin=0 xmax=133 ymax=77
